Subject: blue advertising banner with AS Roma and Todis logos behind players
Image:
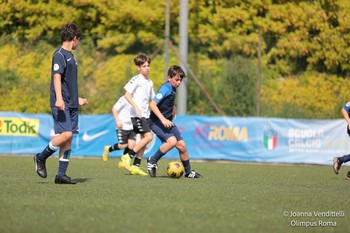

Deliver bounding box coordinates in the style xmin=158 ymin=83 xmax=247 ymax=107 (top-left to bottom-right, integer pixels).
xmin=0 ymin=112 xmax=350 ymax=164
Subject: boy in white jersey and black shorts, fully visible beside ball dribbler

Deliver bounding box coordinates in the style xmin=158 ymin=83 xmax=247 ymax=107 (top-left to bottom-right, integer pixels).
xmin=121 ymin=53 xmax=155 ymax=173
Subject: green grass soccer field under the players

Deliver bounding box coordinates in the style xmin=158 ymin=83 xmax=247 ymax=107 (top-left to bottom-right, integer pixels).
xmin=0 ymin=156 xmax=350 ymax=233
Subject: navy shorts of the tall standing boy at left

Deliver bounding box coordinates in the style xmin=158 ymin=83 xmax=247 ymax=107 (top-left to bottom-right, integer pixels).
xmin=51 ymin=107 xmax=79 ymax=134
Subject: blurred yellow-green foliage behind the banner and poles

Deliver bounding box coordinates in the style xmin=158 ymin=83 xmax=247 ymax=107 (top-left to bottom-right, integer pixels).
xmin=0 ymin=0 xmax=350 ymax=119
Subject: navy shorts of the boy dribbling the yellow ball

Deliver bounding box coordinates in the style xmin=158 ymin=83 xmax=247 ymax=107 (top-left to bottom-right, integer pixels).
xmin=148 ymin=120 xmax=183 ymax=143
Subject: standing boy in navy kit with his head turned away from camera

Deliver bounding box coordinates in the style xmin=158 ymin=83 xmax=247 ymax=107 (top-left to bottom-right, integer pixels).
xmin=34 ymin=24 xmax=88 ymax=184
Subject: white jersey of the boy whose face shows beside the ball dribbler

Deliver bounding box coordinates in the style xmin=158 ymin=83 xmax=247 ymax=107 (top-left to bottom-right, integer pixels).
xmin=124 ymin=74 xmax=155 ymax=118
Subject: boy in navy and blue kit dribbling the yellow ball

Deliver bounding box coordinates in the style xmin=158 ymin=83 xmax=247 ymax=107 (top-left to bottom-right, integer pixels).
xmin=147 ymin=66 xmax=203 ymax=178
